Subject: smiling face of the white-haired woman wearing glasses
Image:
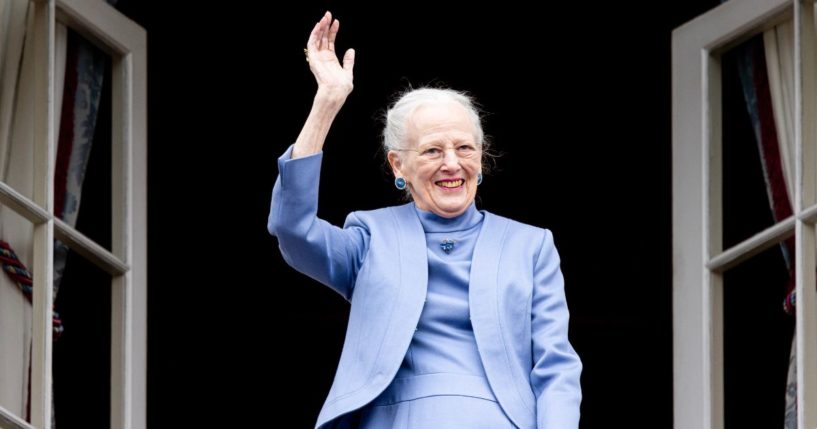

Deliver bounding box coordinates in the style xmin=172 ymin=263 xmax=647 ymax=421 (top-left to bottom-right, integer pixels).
xmin=388 ymin=102 xmax=482 ymax=218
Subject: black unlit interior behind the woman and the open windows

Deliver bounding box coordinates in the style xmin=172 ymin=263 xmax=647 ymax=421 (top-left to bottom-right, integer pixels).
xmin=47 ymin=0 xmax=800 ymax=428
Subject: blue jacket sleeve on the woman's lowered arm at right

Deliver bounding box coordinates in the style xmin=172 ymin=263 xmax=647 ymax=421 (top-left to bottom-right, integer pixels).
xmin=530 ymin=231 xmax=582 ymax=429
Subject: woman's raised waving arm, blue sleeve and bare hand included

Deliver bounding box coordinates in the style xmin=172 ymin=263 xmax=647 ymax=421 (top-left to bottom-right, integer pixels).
xmin=267 ymin=12 xmax=369 ymax=299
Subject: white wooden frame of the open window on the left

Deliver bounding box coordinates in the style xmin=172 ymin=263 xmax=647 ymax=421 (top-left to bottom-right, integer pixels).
xmin=0 ymin=0 xmax=147 ymax=429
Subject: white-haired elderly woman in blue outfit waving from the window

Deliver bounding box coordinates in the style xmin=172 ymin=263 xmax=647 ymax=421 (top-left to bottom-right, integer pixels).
xmin=268 ymin=12 xmax=582 ymax=429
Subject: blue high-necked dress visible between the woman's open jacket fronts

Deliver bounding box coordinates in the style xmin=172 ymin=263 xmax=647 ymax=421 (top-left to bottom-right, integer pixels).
xmin=360 ymin=203 xmax=515 ymax=429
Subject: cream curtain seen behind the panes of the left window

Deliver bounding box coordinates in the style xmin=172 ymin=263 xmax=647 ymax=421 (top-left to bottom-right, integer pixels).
xmin=0 ymin=0 xmax=66 ymax=418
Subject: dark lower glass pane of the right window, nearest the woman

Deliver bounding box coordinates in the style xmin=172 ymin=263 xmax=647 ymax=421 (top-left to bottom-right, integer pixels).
xmin=723 ymin=239 xmax=794 ymax=428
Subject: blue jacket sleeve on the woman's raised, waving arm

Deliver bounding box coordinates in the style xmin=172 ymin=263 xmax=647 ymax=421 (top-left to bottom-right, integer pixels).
xmin=267 ymin=146 xmax=369 ymax=300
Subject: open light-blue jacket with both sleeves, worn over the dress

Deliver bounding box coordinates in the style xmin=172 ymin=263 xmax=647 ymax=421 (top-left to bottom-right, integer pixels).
xmin=268 ymin=147 xmax=582 ymax=429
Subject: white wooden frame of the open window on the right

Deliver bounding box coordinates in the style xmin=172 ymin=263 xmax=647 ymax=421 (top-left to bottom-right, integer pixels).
xmin=672 ymin=0 xmax=817 ymax=429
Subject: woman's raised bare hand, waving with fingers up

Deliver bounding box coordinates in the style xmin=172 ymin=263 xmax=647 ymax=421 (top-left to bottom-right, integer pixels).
xmin=306 ymin=12 xmax=355 ymax=100
